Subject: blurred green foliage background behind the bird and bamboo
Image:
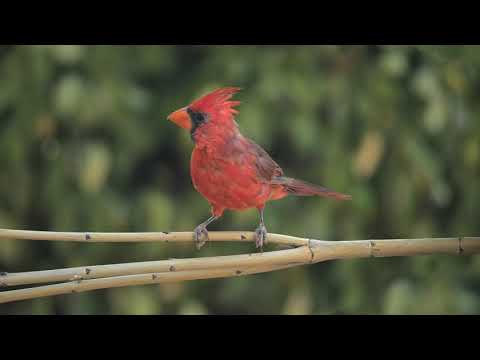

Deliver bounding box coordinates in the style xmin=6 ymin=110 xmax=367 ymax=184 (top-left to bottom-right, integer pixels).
xmin=0 ymin=45 xmax=480 ymax=314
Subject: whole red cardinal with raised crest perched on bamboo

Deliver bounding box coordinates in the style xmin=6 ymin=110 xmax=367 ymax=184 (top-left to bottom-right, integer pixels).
xmin=168 ymin=87 xmax=351 ymax=249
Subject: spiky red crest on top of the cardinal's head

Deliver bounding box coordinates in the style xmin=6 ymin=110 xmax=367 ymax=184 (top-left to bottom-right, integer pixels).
xmin=190 ymin=87 xmax=241 ymax=115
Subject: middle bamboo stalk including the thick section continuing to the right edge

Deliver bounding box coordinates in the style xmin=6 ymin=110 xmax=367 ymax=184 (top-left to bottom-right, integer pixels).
xmin=0 ymin=238 xmax=480 ymax=286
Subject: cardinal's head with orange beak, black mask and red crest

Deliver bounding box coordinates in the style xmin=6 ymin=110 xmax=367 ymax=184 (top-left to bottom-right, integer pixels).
xmin=167 ymin=87 xmax=240 ymax=133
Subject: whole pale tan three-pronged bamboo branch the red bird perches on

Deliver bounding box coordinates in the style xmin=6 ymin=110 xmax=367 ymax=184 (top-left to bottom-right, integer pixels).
xmin=0 ymin=230 xmax=480 ymax=303
